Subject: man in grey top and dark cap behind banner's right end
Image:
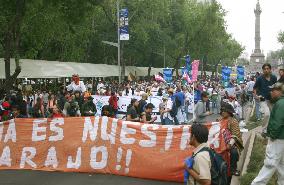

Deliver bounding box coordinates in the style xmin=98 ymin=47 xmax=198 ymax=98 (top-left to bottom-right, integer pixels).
xmin=194 ymin=92 xmax=213 ymax=124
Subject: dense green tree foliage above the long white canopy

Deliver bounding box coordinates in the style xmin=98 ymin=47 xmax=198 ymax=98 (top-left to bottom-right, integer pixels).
xmin=0 ymin=0 xmax=244 ymax=70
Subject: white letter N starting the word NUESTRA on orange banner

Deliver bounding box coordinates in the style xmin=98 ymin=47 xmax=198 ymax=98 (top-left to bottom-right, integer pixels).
xmin=82 ymin=116 xmax=100 ymax=143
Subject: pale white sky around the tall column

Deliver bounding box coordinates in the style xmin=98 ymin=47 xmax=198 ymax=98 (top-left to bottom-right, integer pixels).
xmin=217 ymin=0 xmax=284 ymax=56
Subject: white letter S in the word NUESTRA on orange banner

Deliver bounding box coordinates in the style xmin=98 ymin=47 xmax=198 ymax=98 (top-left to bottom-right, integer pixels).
xmin=139 ymin=124 xmax=159 ymax=148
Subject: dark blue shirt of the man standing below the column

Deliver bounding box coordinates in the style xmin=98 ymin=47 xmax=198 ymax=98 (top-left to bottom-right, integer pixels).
xmin=253 ymin=75 xmax=277 ymax=100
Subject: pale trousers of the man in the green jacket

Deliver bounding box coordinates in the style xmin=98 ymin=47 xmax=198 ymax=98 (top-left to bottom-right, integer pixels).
xmin=251 ymin=139 xmax=284 ymax=185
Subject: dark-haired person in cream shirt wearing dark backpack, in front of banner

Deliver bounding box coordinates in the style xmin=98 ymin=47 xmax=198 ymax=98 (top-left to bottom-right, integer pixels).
xmin=184 ymin=123 xmax=229 ymax=185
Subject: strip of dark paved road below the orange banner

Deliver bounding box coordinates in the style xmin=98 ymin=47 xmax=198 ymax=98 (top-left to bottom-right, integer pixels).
xmin=0 ymin=170 xmax=183 ymax=185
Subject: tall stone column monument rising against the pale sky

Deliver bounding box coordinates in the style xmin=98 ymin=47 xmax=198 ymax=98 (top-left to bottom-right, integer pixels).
xmin=250 ymin=0 xmax=265 ymax=71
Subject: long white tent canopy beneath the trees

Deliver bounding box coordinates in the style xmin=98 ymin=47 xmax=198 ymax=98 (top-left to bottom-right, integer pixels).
xmin=0 ymin=58 xmax=209 ymax=79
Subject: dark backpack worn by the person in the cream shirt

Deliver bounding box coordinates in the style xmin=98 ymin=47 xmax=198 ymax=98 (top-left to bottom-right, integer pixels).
xmin=193 ymin=147 xmax=228 ymax=185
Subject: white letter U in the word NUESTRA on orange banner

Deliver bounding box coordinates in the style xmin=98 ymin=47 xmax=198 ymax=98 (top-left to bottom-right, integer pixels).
xmin=101 ymin=117 xmax=117 ymax=144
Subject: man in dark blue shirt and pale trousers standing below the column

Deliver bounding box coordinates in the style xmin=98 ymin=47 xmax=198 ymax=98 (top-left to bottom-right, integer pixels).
xmin=254 ymin=63 xmax=277 ymax=135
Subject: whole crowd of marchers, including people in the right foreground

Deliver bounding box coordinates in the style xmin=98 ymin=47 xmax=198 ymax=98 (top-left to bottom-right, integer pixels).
xmin=0 ymin=64 xmax=284 ymax=184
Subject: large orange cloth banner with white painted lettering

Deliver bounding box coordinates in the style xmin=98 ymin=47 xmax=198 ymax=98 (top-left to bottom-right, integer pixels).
xmin=0 ymin=117 xmax=227 ymax=182
